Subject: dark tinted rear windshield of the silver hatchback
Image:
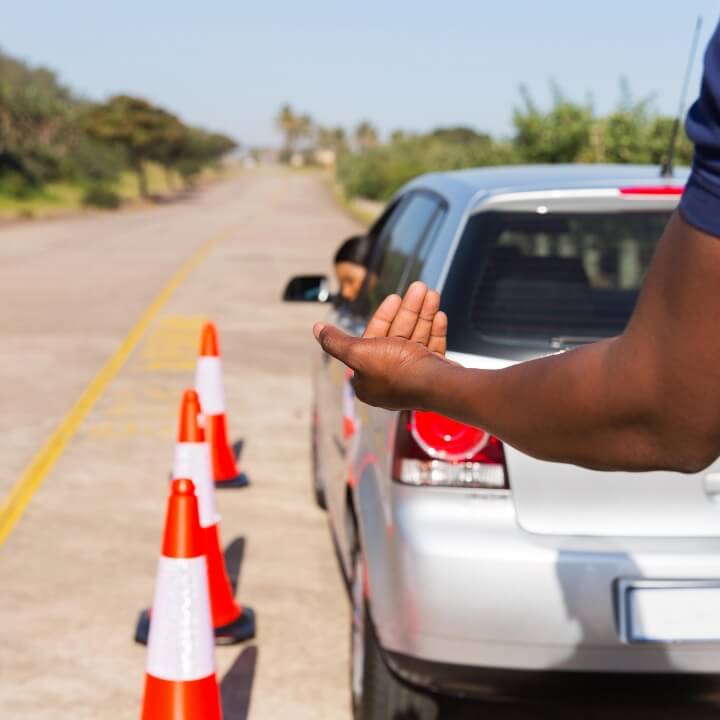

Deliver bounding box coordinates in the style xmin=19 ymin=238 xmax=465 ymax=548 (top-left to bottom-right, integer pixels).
xmin=443 ymin=211 xmax=670 ymax=357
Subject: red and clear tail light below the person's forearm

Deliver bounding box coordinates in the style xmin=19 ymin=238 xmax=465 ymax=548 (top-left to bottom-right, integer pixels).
xmin=393 ymin=410 xmax=509 ymax=490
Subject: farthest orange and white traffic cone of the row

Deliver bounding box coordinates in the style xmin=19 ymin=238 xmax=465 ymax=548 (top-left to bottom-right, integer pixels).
xmin=195 ymin=322 xmax=249 ymax=488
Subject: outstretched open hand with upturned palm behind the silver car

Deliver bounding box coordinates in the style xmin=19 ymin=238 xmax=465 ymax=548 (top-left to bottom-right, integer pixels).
xmin=313 ymin=282 xmax=454 ymax=410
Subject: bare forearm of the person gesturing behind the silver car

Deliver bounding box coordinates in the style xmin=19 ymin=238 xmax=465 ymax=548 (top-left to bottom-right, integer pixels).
xmin=428 ymin=338 xmax=667 ymax=470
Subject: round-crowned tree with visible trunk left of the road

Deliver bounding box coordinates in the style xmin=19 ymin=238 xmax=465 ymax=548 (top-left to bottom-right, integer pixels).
xmin=83 ymin=95 xmax=183 ymax=197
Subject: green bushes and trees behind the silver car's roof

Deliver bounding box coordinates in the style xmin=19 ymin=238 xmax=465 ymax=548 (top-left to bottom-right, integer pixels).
xmin=277 ymin=82 xmax=692 ymax=200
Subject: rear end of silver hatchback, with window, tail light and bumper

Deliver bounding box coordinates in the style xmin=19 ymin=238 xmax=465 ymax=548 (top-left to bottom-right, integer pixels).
xmin=361 ymin=170 xmax=720 ymax=691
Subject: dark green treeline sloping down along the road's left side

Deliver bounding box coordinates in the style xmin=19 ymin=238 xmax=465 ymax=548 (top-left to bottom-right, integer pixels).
xmin=0 ymin=52 xmax=236 ymax=206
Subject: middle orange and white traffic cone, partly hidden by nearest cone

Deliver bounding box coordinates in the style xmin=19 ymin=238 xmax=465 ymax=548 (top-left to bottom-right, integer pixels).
xmin=135 ymin=390 xmax=255 ymax=645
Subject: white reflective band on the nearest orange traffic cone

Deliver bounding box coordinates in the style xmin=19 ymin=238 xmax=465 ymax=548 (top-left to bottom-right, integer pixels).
xmin=145 ymin=555 xmax=215 ymax=680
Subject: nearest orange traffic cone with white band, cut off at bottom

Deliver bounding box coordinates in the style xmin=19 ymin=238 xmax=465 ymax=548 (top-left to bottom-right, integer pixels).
xmin=142 ymin=480 xmax=222 ymax=720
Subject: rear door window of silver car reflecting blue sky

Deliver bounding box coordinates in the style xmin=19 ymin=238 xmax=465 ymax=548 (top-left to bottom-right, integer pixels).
xmin=368 ymin=192 xmax=441 ymax=314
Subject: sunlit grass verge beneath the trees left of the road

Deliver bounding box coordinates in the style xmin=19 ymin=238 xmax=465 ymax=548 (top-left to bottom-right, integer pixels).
xmin=0 ymin=163 xmax=232 ymax=219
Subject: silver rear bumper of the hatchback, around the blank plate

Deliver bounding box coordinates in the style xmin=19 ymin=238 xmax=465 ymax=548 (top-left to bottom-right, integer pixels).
xmin=359 ymin=482 xmax=720 ymax=674
